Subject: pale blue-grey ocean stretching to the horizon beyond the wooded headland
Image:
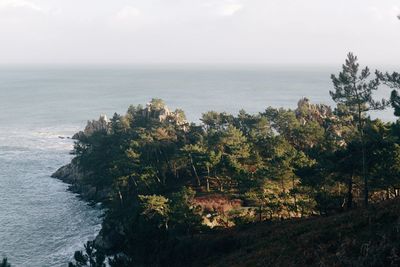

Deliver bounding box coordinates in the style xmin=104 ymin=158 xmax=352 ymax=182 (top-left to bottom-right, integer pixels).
xmin=0 ymin=66 xmax=393 ymax=266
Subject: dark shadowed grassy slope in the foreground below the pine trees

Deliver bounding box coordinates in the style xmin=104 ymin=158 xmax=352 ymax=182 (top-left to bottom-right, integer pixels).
xmin=176 ymin=199 xmax=400 ymax=266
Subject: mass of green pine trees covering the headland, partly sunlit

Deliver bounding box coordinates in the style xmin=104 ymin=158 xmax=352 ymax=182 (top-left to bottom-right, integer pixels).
xmin=65 ymin=54 xmax=400 ymax=266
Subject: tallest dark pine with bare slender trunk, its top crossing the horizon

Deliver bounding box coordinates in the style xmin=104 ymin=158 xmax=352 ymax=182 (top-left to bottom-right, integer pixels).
xmin=329 ymin=53 xmax=387 ymax=207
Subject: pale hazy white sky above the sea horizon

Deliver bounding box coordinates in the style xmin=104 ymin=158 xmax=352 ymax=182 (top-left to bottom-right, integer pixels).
xmin=0 ymin=0 xmax=400 ymax=65
